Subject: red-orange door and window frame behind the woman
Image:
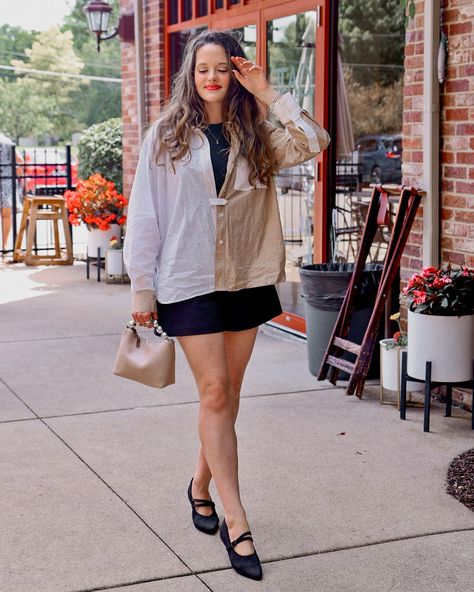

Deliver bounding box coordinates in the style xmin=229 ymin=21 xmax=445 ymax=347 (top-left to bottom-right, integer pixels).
xmin=164 ymin=0 xmax=331 ymax=333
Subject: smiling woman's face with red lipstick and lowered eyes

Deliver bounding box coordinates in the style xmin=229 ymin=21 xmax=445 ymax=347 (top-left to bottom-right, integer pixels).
xmin=194 ymin=43 xmax=231 ymax=110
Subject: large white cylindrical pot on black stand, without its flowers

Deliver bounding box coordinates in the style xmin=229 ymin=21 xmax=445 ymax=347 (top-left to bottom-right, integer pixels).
xmin=407 ymin=311 xmax=474 ymax=383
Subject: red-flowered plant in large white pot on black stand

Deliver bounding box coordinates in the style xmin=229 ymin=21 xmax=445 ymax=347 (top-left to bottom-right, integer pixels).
xmin=403 ymin=264 xmax=474 ymax=383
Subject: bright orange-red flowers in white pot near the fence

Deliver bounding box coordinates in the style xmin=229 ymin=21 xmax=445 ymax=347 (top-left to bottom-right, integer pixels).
xmin=64 ymin=173 xmax=127 ymax=257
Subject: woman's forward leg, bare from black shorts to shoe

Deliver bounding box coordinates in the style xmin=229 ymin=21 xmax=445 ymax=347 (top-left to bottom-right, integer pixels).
xmin=178 ymin=329 xmax=256 ymax=554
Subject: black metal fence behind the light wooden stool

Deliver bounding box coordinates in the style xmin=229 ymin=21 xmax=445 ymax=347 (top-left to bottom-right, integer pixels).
xmin=0 ymin=144 xmax=75 ymax=257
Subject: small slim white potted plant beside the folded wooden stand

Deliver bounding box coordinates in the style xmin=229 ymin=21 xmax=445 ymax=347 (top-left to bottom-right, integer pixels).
xmin=379 ymin=312 xmax=422 ymax=403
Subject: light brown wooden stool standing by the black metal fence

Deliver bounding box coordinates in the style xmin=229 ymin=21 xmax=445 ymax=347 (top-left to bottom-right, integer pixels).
xmin=13 ymin=195 xmax=73 ymax=265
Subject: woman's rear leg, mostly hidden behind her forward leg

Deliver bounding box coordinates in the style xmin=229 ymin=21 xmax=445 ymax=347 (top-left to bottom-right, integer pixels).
xmin=192 ymin=327 xmax=257 ymax=516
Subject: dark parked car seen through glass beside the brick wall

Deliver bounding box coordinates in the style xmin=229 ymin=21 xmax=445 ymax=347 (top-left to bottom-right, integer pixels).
xmin=356 ymin=134 xmax=403 ymax=183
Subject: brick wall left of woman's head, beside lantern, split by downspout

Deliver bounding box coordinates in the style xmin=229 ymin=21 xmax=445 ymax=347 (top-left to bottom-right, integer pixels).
xmin=121 ymin=0 xmax=165 ymax=196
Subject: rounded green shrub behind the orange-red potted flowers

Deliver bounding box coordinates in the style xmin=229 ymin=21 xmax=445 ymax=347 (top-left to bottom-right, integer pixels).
xmin=79 ymin=117 xmax=123 ymax=193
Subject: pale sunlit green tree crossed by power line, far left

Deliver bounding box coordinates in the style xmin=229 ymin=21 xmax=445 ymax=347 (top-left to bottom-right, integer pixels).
xmin=11 ymin=27 xmax=86 ymax=139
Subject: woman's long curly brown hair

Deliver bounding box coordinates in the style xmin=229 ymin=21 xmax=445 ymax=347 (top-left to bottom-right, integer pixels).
xmin=154 ymin=31 xmax=276 ymax=185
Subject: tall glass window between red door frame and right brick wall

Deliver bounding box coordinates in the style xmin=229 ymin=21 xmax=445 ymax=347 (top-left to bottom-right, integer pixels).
xmin=331 ymin=0 xmax=405 ymax=262
